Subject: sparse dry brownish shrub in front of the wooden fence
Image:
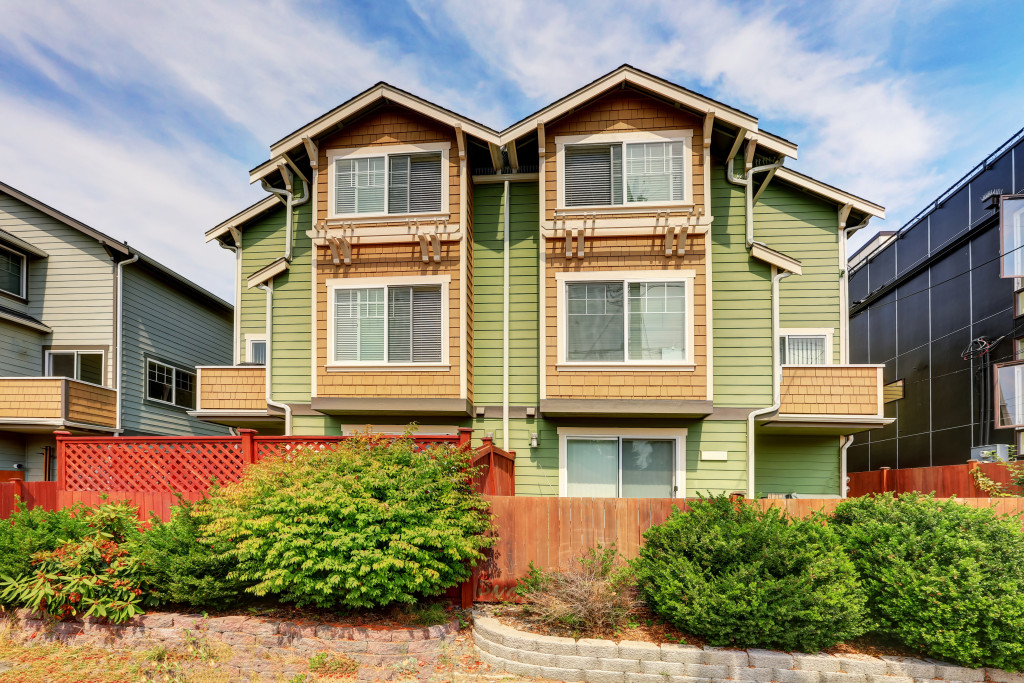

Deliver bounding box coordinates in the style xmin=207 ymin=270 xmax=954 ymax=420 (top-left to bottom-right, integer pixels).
xmin=516 ymin=544 xmax=638 ymax=631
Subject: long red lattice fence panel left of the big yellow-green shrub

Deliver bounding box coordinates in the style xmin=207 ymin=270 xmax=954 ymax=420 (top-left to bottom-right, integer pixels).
xmin=63 ymin=437 xmax=245 ymax=494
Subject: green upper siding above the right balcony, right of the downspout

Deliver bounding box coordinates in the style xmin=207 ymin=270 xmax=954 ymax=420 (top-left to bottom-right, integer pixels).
xmin=754 ymin=181 xmax=840 ymax=362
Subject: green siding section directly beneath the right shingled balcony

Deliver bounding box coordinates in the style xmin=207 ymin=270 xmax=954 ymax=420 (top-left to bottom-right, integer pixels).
xmin=755 ymin=435 xmax=840 ymax=496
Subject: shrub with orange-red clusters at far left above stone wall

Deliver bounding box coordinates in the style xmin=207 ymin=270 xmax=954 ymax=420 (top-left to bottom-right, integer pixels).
xmin=0 ymin=503 xmax=153 ymax=624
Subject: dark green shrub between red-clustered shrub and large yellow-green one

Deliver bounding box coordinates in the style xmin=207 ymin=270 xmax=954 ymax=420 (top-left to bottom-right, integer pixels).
xmin=131 ymin=488 xmax=247 ymax=609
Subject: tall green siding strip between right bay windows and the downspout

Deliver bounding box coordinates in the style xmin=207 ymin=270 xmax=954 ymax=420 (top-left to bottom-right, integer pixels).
xmin=711 ymin=165 xmax=771 ymax=405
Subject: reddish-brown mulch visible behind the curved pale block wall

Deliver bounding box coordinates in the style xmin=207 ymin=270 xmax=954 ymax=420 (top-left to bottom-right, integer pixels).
xmin=477 ymin=603 xmax=922 ymax=658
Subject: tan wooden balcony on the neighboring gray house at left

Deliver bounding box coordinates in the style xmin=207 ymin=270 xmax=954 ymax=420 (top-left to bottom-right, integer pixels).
xmin=0 ymin=377 xmax=118 ymax=433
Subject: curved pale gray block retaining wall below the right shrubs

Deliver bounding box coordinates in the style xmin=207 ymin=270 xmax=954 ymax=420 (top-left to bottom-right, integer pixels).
xmin=473 ymin=614 xmax=1024 ymax=683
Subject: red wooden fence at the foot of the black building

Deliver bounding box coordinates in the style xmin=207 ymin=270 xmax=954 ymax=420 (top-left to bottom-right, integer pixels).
xmin=849 ymin=462 xmax=1013 ymax=498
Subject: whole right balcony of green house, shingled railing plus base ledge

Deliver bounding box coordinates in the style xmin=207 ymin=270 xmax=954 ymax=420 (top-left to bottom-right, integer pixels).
xmin=760 ymin=366 xmax=892 ymax=434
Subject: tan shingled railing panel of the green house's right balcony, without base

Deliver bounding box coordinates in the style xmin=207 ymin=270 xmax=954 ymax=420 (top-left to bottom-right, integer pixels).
xmin=778 ymin=366 xmax=883 ymax=417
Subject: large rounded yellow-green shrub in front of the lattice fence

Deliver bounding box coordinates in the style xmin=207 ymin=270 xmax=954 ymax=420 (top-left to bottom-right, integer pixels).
xmin=203 ymin=435 xmax=493 ymax=608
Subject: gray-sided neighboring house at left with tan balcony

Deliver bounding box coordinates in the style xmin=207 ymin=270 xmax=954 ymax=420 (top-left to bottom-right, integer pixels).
xmin=0 ymin=182 xmax=233 ymax=481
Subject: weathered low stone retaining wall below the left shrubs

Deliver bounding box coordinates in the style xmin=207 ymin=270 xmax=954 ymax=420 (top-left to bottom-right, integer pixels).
xmin=7 ymin=609 xmax=459 ymax=680
